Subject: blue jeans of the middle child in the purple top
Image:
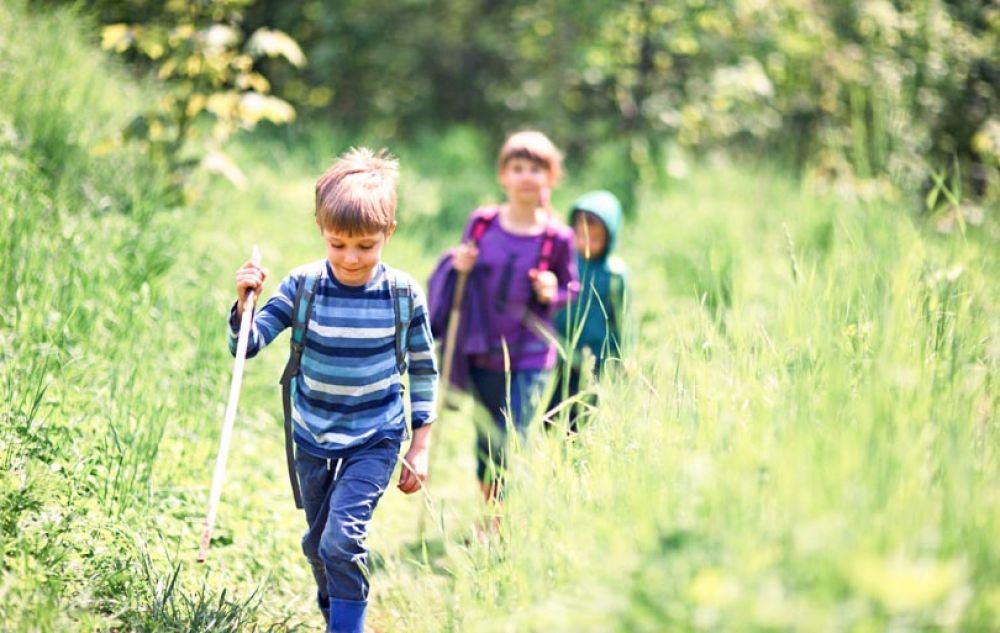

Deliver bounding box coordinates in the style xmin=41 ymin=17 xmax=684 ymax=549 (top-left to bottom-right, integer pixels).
xmin=469 ymin=367 xmax=549 ymax=483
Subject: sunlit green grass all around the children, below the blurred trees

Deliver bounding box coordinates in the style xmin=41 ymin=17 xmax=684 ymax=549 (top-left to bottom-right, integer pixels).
xmin=0 ymin=2 xmax=1000 ymax=633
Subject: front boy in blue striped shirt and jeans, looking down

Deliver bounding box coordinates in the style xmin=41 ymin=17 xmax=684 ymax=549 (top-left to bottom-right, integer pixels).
xmin=236 ymin=148 xmax=437 ymax=633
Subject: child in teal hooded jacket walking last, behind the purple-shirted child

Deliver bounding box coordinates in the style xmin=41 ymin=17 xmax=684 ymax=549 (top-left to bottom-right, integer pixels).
xmin=549 ymin=191 xmax=627 ymax=431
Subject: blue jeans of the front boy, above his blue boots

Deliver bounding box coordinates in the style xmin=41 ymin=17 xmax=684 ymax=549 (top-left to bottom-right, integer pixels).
xmin=295 ymin=440 xmax=399 ymax=607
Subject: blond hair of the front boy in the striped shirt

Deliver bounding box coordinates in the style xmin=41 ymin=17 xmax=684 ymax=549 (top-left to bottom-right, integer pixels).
xmin=316 ymin=147 xmax=399 ymax=236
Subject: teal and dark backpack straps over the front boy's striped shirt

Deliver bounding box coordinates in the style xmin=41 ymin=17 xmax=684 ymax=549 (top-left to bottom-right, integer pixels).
xmin=280 ymin=264 xmax=413 ymax=509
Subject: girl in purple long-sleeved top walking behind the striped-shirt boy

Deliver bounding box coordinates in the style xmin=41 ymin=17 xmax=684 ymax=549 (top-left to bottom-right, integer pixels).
xmin=445 ymin=131 xmax=578 ymax=501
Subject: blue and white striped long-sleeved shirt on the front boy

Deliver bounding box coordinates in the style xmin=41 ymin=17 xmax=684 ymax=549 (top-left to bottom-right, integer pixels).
xmin=229 ymin=260 xmax=438 ymax=458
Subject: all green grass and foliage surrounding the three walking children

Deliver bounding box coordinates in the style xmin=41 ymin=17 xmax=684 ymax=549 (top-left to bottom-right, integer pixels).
xmin=0 ymin=0 xmax=1000 ymax=633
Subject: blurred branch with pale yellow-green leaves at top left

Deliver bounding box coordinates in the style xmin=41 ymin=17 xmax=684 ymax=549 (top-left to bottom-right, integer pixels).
xmin=101 ymin=0 xmax=305 ymax=186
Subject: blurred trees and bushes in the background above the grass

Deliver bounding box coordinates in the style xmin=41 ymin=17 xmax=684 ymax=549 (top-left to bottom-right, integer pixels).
xmin=41 ymin=0 xmax=1000 ymax=209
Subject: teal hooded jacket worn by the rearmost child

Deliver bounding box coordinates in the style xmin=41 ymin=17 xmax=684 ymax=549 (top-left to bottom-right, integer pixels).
xmin=555 ymin=191 xmax=628 ymax=372
